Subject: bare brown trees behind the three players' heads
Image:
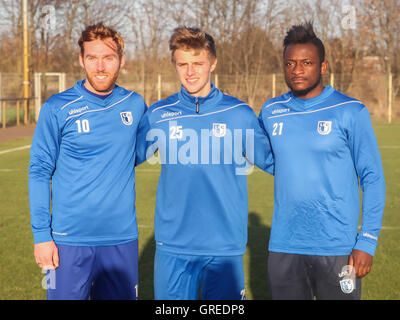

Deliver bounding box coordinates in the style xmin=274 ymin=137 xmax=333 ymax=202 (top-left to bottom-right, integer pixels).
xmin=0 ymin=0 xmax=400 ymax=112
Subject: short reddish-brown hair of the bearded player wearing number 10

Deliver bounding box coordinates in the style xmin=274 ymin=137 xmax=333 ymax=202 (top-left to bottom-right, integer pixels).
xmin=78 ymin=22 xmax=124 ymax=58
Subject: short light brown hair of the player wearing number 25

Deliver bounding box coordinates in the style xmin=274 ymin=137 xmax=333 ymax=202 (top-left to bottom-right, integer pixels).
xmin=169 ymin=26 xmax=217 ymax=62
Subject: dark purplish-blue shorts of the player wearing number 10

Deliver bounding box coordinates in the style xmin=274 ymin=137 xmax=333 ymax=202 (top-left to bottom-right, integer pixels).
xmin=46 ymin=240 xmax=138 ymax=300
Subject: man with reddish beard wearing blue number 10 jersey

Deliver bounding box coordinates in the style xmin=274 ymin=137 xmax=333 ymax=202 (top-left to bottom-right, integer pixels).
xmin=29 ymin=23 xmax=147 ymax=300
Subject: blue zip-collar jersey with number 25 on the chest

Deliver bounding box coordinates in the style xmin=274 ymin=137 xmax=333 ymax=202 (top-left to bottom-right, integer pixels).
xmin=137 ymin=84 xmax=273 ymax=256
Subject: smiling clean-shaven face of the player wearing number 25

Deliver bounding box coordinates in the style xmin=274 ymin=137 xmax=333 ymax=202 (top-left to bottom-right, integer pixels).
xmin=173 ymin=49 xmax=217 ymax=97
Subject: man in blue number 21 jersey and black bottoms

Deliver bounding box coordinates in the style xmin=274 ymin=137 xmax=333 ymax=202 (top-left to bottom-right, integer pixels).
xmin=259 ymin=23 xmax=385 ymax=299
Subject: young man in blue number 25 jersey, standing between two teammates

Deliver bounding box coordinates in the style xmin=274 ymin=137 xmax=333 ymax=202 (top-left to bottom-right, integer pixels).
xmin=137 ymin=27 xmax=272 ymax=300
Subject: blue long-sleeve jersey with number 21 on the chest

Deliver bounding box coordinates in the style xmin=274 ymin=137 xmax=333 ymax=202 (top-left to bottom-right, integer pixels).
xmin=259 ymin=86 xmax=385 ymax=256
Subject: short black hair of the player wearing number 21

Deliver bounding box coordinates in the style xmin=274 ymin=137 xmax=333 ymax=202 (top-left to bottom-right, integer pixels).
xmin=283 ymin=21 xmax=325 ymax=63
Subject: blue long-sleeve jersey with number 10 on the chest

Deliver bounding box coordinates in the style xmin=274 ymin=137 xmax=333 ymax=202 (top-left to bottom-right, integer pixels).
xmin=29 ymin=81 xmax=147 ymax=246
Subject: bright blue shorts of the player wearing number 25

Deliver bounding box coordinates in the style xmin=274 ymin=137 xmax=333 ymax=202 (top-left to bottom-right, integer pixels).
xmin=154 ymin=249 xmax=245 ymax=300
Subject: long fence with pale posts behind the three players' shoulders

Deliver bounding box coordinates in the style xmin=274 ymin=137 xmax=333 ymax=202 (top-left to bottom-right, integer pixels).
xmin=0 ymin=72 xmax=400 ymax=128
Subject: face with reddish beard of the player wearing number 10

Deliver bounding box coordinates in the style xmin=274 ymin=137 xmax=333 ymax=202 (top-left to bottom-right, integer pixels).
xmin=79 ymin=38 xmax=125 ymax=95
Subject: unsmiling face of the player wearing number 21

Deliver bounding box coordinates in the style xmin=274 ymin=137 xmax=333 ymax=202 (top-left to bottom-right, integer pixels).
xmin=284 ymin=43 xmax=328 ymax=99
